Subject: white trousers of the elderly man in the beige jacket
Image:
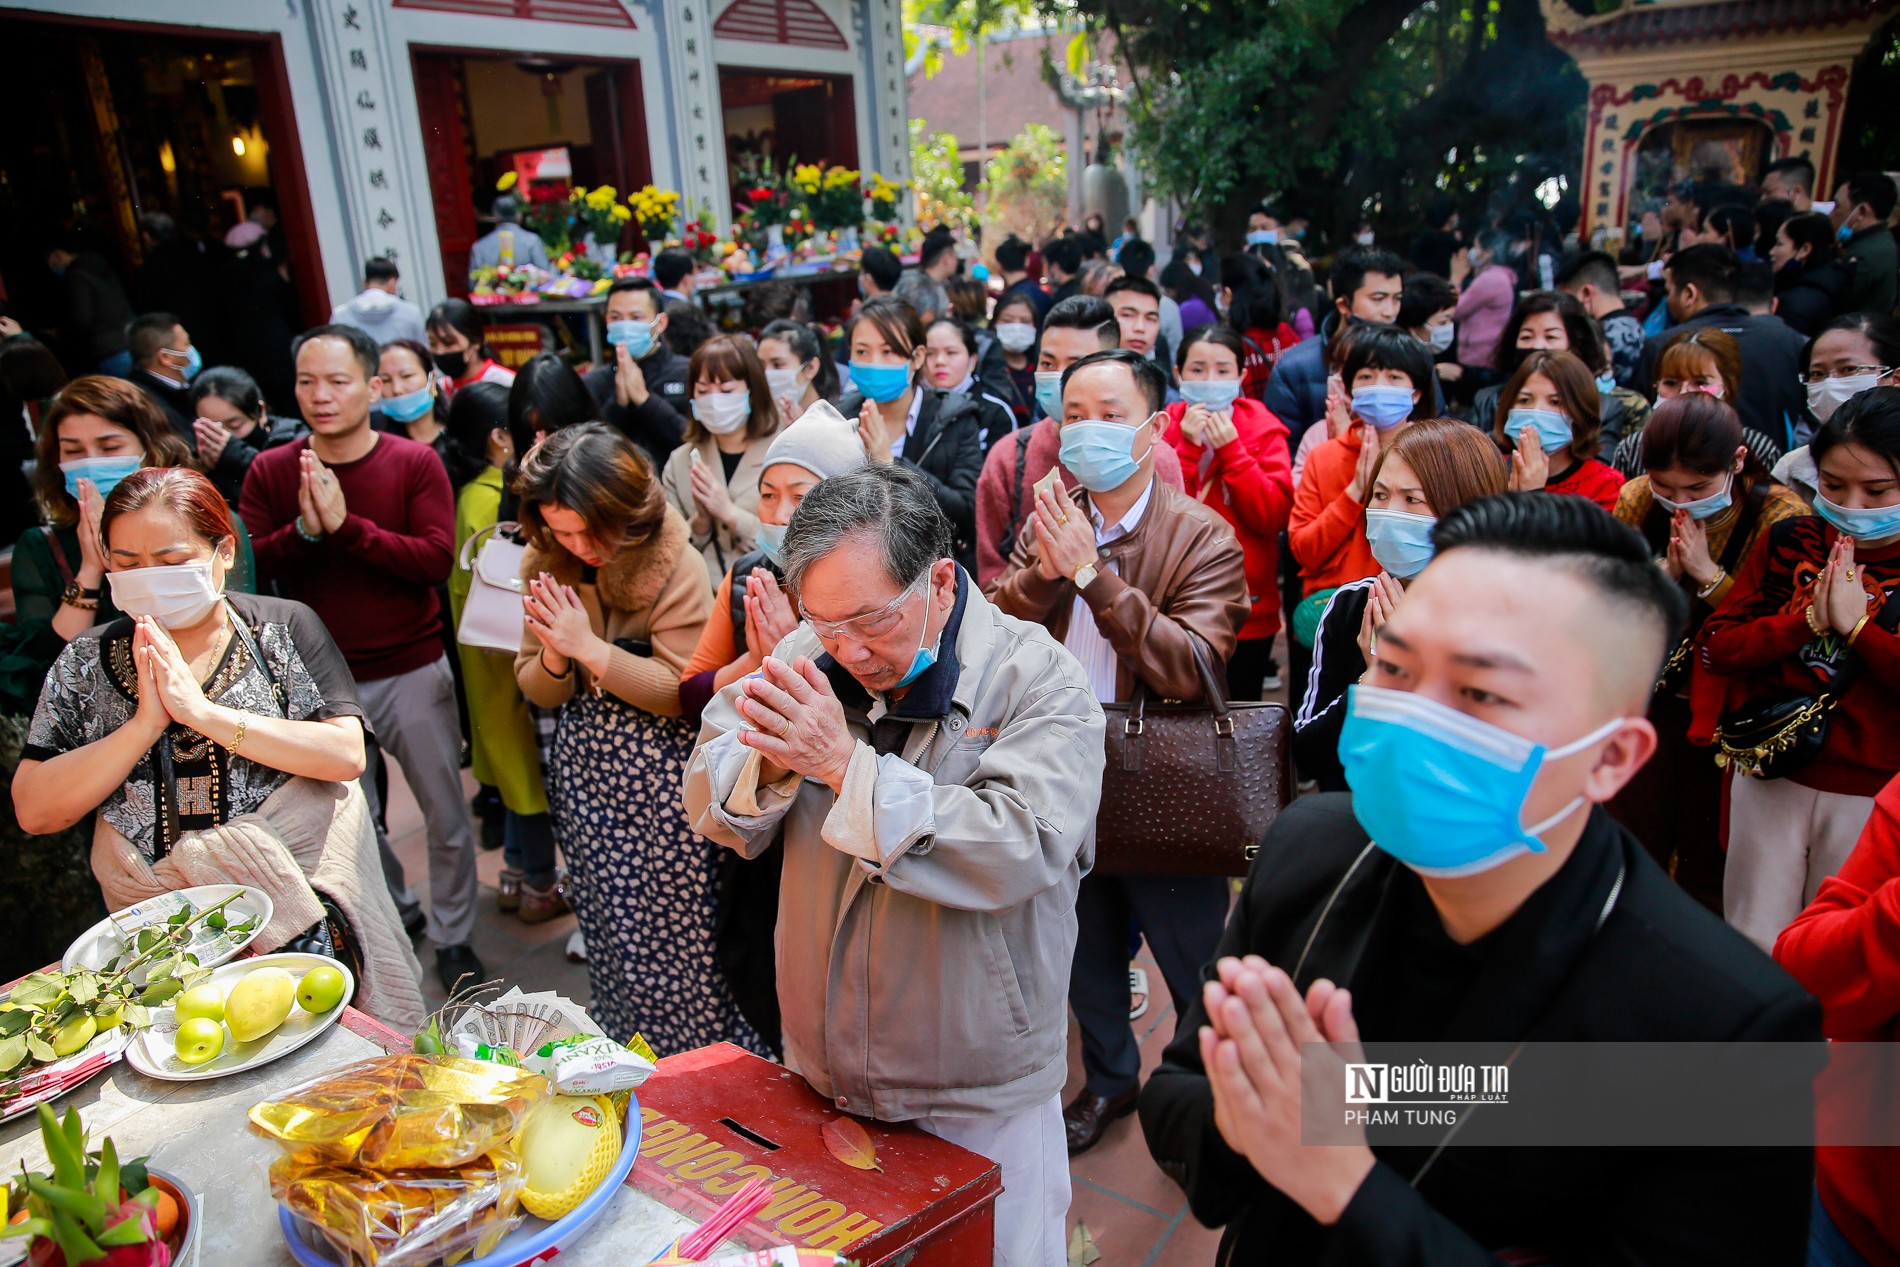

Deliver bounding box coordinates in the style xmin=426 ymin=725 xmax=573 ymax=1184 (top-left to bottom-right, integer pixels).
xmin=916 ymin=1094 xmax=1070 ymax=1267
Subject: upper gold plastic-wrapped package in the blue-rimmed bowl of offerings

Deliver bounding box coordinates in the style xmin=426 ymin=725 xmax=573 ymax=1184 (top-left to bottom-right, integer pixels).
xmin=251 ymin=1052 xmax=551 ymax=1170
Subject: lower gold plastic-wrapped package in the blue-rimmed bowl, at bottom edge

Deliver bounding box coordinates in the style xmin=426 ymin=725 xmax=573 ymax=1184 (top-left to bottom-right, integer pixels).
xmin=270 ymin=1145 xmax=523 ymax=1267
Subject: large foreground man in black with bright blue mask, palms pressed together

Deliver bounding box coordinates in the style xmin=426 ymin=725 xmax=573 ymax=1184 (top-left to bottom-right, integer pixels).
xmin=1140 ymin=494 xmax=1820 ymax=1267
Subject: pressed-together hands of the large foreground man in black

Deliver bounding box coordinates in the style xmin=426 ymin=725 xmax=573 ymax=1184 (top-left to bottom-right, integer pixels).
xmin=1201 ymin=955 xmax=1374 ymax=1223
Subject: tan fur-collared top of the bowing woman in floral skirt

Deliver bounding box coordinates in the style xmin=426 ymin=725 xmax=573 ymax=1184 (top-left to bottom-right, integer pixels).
xmin=515 ymin=507 xmax=713 ymax=716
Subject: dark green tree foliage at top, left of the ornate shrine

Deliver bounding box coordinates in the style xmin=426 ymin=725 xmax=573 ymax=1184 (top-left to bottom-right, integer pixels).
xmin=1074 ymin=0 xmax=1585 ymax=245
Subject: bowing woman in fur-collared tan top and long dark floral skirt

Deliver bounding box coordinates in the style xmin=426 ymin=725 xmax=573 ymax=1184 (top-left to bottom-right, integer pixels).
xmin=515 ymin=422 xmax=764 ymax=1054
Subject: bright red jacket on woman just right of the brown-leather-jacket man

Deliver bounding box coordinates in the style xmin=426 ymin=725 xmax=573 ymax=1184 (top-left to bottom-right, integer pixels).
xmin=1163 ymin=395 xmax=1294 ymax=640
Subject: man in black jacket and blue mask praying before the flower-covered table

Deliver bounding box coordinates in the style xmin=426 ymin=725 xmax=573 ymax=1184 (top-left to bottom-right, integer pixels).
xmin=581 ymin=277 xmax=694 ymax=467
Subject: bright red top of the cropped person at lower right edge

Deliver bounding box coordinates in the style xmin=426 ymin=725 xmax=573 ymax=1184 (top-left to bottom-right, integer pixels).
xmin=1775 ymin=775 xmax=1900 ymax=1267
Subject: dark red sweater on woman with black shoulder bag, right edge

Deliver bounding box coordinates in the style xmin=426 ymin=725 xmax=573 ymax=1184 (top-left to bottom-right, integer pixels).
xmin=1702 ymin=515 xmax=1900 ymax=796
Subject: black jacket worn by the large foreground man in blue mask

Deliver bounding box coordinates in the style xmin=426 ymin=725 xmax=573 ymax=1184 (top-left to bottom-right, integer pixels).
xmin=1140 ymin=794 xmax=1820 ymax=1267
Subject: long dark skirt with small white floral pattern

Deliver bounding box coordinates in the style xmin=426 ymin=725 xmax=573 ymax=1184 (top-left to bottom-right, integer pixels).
xmin=547 ymin=693 xmax=770 ymax=1056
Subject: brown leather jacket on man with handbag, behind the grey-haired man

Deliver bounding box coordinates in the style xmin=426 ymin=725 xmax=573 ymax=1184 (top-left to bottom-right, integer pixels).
xmin=988 ymin=481 xmax=1248 ymax=699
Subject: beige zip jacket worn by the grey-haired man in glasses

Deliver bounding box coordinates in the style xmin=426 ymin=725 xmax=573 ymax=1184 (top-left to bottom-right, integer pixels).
xmin=686 ymin=576 xmax=1104 ymax=1121
